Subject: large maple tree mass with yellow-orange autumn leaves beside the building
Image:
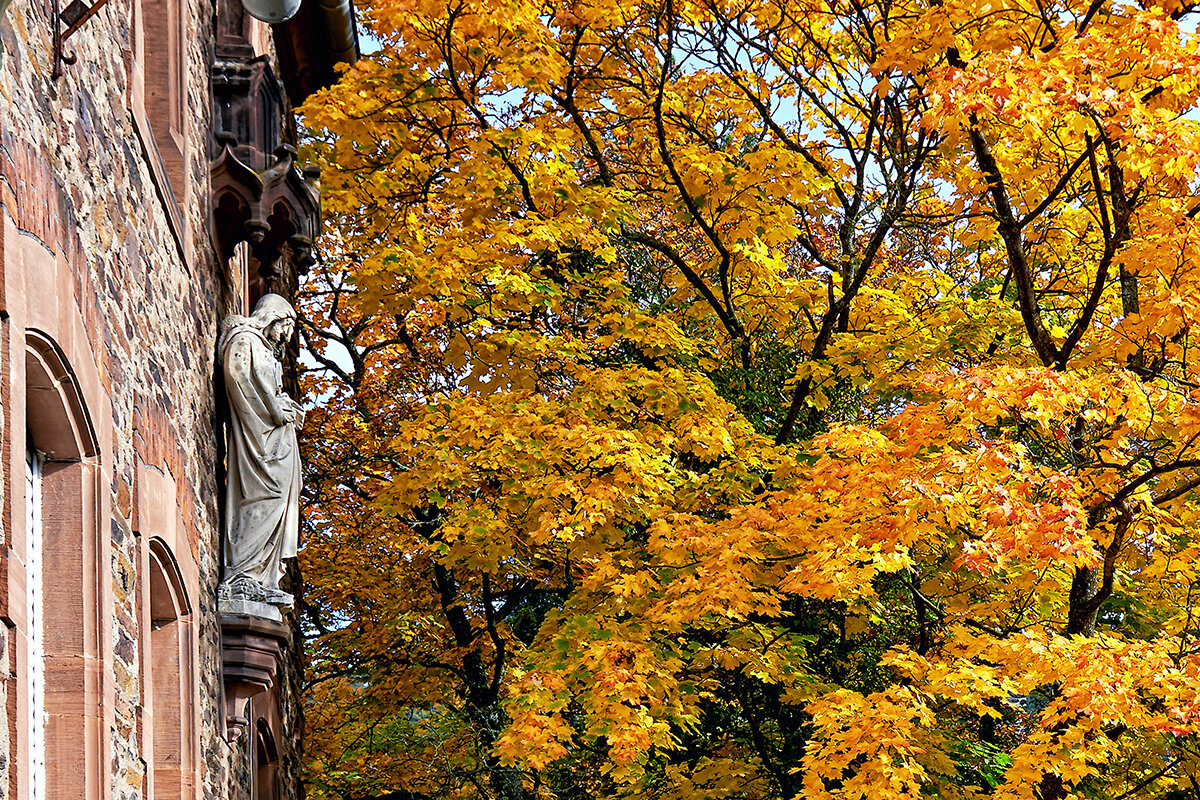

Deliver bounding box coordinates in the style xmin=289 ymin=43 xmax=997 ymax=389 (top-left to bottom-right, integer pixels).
xmin=305 ymin=0 xmax=1200 ymax=800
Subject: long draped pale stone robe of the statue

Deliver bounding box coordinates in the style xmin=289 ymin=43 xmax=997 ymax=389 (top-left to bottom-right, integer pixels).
xmin=220 ymin=318 xmax=300 ymax=589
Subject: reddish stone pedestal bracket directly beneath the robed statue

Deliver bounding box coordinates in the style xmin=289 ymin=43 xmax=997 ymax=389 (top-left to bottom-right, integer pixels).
xmin=220 ymin=609 xmax=292 ymax=741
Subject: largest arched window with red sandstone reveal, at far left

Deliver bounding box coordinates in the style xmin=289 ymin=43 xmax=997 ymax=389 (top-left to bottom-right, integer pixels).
xmin=18 ymin=330 xmax=108 ymax=800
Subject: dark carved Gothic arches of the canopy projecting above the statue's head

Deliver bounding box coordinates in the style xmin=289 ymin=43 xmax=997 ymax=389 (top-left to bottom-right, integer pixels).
xmin=211 ymin=136 xmax=320 ymax=279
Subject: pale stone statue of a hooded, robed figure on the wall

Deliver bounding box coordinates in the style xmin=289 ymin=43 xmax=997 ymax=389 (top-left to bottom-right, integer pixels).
xmin=217 ymin=294 xmax=304 ymax=616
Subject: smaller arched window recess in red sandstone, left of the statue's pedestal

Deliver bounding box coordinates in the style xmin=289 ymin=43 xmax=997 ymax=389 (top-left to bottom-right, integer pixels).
xmin=144 ymin=537 xmax=196 ymax=800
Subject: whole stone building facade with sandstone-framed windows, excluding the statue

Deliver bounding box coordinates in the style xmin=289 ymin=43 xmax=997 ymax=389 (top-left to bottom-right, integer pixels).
xmin=0 ymin=0 xmax=356 ymax=800
